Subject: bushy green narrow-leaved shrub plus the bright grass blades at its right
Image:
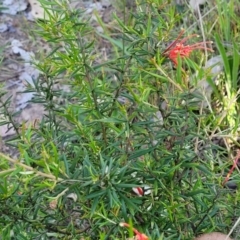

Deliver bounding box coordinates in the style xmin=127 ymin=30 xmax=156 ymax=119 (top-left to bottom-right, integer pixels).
xmin=0 ymin=0 xmax=240 ymax=239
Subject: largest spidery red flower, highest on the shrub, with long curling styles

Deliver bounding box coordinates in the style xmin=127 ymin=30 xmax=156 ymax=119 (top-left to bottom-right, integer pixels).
xmin=163 ymin=30 xmax=213 ymax=66
